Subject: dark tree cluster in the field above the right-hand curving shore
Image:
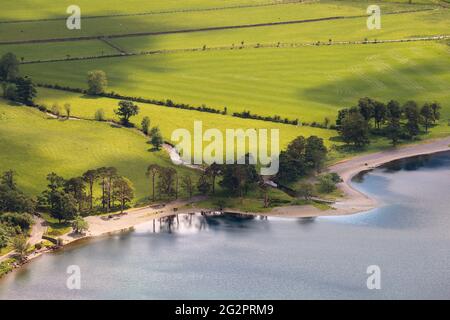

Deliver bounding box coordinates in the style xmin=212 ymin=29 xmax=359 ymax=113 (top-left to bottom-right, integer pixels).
xmin=336 ymin=98 xmax=441 ymax=147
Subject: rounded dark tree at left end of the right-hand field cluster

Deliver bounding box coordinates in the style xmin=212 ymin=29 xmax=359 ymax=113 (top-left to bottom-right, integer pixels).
xmin=339 ymin=111 xmax=370 ymax=147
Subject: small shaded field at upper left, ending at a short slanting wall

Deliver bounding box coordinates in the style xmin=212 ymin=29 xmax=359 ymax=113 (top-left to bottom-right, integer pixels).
xmin=0 ymin=40 xmax=118 ymax=61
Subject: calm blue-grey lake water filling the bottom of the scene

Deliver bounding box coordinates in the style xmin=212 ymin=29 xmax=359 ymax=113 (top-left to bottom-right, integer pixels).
xmin=0 ymin=153 xmax=450 ymax=299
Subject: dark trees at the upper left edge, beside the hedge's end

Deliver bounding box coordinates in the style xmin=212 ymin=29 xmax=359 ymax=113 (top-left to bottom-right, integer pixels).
xmin=0 ymin=53 xmax=36 ymax=105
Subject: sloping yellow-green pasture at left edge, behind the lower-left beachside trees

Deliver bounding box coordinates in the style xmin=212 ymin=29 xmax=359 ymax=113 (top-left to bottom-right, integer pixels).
xmin=0 ymin=101 xmax=193 ymax=200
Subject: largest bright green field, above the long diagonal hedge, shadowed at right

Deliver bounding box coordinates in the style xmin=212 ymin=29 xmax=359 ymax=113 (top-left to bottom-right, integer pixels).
xmin=22 ymin=42 xmax=450 ymax=122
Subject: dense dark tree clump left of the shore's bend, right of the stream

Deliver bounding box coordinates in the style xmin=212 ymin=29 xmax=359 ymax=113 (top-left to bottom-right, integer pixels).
xmin=275 ymin=136 xmax=328 ymax=183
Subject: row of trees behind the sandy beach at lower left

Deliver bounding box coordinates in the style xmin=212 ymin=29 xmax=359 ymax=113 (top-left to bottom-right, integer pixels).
xmin=39 ymin=167 xmax=134 ymax=221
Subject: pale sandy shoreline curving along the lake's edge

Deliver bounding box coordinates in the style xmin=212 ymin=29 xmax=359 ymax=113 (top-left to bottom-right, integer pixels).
xmin=0 ymin=137 xmax=450 ymax=271
